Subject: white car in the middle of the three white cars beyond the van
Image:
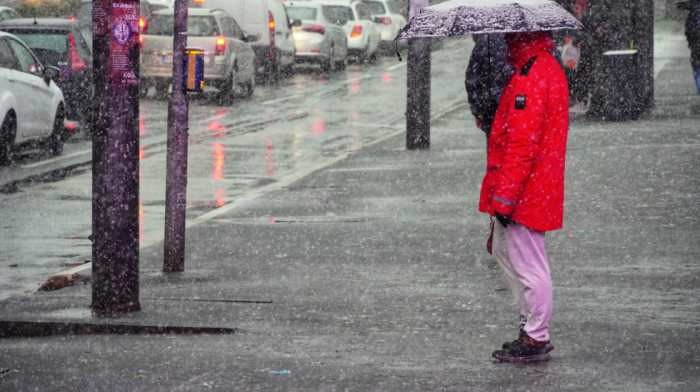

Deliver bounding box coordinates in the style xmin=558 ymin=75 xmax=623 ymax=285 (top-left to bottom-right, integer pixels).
xmin=328 ymin=0 xmax=381 ymax=61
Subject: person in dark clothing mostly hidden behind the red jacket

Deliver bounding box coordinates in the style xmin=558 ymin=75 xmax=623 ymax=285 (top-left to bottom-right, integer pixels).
xmin=464 ymin=34 xmax=514 ymax=137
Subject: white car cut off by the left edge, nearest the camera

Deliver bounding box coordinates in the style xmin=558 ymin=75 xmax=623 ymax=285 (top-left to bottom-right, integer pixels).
xmin=0 ymin=32 xmax=66 ymax=165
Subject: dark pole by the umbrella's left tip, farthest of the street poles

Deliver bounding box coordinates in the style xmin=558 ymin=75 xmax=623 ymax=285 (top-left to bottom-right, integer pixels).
xmin=406 ymin=0 xmax=430 ymax=150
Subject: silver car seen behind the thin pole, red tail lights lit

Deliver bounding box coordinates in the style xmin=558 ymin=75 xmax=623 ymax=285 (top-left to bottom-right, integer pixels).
xmin=140 ymin=8 xmax=256 ymax=103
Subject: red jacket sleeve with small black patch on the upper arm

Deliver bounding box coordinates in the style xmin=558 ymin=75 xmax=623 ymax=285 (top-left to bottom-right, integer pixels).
xmin=493 ymin=66 xmax=547 ymax=215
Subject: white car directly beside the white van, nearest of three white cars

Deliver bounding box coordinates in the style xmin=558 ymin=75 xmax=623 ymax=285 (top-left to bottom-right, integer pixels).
xmin=284 ymin=0 xmax=348 ymax=71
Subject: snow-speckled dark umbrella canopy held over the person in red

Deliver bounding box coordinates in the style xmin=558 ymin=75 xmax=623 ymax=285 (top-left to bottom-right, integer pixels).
xmin=396 ymin=0 xmax=583 ymax=39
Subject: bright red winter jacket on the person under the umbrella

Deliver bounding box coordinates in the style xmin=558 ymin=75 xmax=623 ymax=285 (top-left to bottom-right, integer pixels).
xmin=479 ymin=33 xmax=569 ymax=231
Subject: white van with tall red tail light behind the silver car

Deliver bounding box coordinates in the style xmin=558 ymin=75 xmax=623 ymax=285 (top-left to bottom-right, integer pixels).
xmin=190 ymin=0 xmax=296 ymax=80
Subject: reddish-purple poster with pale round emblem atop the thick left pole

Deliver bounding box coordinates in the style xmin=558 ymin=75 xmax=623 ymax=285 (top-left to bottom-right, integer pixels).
xmin=109 ymin=0 xmax=139 ymax=86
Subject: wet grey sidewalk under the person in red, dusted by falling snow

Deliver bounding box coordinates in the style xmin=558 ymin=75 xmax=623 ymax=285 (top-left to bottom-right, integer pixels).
xmin=0 ymin=26 xmax=700 ymax=391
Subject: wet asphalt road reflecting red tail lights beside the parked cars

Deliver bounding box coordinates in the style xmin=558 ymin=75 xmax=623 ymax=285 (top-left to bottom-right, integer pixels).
xmin=0 ymin=37 xmax=472 ymax=298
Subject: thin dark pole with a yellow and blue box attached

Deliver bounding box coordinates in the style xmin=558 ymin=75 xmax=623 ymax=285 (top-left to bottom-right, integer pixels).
xmin=163 ymin=0 xmax=189 ymax=272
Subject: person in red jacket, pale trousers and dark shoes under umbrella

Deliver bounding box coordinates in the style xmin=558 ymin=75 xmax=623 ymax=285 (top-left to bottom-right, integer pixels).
xmin=479 ymin=31 xmax=569 ymax=362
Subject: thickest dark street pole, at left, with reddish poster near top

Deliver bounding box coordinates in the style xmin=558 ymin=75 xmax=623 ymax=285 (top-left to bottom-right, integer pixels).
xmin=91 ymin=0 xmax=141 ymax=315
